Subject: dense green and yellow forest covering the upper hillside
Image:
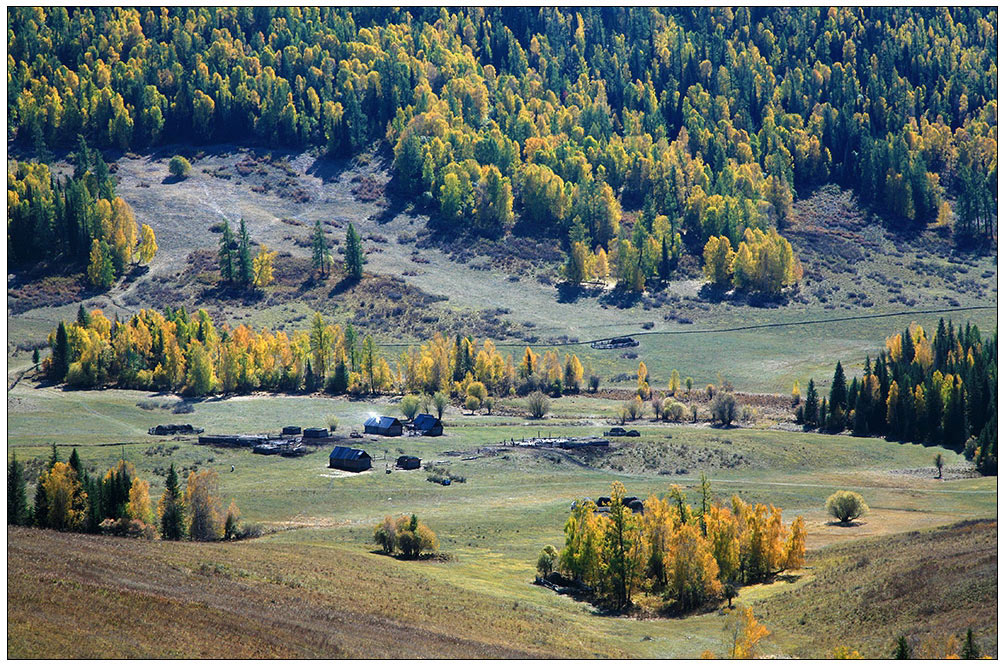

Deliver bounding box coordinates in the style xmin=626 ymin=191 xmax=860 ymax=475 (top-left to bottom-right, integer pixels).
xmin=7 ymin=7 xmax=997 ymax=290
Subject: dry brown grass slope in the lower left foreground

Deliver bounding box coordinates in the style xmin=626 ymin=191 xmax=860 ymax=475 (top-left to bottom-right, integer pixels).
xmin=7 ymin=528 xmax=616 ymax=659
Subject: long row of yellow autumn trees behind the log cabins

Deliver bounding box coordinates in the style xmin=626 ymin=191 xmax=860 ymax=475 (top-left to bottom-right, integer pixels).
xmin=44 ymin=308 xmax=584 ymax=402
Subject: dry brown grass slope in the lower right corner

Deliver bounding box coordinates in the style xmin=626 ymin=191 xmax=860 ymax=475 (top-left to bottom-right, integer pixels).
xmin=755 ymin=520 xmax=998 ymax=659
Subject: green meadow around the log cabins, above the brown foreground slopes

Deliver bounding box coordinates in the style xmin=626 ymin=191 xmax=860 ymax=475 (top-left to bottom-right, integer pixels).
xmin=8 ymin=386 xmax=997 ymax=658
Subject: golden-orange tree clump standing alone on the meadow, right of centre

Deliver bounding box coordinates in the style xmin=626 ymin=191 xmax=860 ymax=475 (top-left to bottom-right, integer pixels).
xmin=558 ymin=482 xmax=806 ymax=612
